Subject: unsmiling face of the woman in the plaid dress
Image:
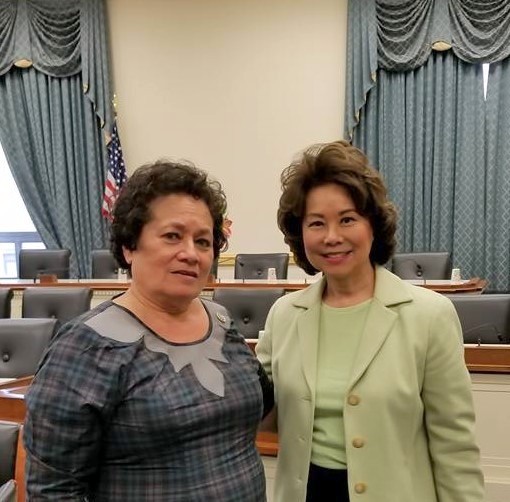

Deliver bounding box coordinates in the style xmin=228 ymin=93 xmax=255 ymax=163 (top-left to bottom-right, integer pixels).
xmin=124 ymin=194 xmax=213 ymax=305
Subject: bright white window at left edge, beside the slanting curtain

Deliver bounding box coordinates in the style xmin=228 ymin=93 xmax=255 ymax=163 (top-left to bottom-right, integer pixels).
xmin=0 ymin=145 xmax=45 ymax=279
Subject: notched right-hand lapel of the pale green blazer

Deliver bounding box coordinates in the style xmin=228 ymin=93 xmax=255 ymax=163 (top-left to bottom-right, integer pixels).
xmin=348 ymin=267 xmax=412 ymax=388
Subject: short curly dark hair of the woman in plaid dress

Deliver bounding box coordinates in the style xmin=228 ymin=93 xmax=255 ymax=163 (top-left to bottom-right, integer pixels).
xmin=110 ymin=160 xmax=227 ymax=270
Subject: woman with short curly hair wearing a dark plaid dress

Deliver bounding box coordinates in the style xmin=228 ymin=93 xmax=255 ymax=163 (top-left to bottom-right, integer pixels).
xmin=24 ymin=162 xmax=273 ymax=502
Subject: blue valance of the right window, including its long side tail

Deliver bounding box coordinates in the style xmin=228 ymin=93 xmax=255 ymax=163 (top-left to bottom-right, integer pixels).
xmin=345 ymin=0 xmax=510 ymax=137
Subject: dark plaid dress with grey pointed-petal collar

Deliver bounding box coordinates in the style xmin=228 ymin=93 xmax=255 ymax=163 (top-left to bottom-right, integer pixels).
xmin=24 ymin=301 xmax=266 ymax=502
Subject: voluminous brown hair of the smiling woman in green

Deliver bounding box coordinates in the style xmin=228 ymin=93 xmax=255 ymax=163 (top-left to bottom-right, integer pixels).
xmin=278 ymin=140 xmax=397 ymax=274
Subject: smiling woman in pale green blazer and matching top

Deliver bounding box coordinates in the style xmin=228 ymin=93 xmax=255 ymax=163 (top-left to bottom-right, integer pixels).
xmin=257 ymin=141 xmax=484 ymax=502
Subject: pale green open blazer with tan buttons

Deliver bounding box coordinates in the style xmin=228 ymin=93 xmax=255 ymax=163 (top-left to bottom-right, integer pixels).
xmin=256 ymin=267 xmax=484 ymax=502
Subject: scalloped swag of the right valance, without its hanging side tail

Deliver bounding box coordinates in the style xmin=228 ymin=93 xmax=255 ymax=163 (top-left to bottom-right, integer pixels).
xmin=374 ymin=0 xmax=510 ymax=71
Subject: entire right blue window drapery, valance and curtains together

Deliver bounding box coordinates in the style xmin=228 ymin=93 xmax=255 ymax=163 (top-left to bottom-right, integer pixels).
xmin=345 ymin=0 xmax=510 ymax=291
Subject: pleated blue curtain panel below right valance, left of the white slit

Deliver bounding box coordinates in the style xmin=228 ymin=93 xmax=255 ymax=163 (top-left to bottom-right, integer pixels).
xmin=353 ymin=52 xmax=494 ymax=287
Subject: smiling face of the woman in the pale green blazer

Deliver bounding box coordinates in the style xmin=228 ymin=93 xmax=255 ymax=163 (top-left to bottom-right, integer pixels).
xmin=302 ymin=184 xmax=374 ymax=280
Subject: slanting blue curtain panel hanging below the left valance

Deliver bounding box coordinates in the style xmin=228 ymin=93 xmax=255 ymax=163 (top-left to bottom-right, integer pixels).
xmin=0 ymin=68 xmax=107 ymax=277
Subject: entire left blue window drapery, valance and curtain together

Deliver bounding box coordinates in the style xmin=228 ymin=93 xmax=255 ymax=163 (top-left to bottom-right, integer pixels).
xmin=0 ymin=0 xmax=114 ymax=277
